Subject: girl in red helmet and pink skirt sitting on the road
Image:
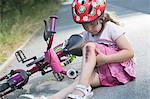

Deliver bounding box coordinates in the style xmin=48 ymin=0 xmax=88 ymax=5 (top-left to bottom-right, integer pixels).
xmin=20 ymin=0 xmax=135 ymax=99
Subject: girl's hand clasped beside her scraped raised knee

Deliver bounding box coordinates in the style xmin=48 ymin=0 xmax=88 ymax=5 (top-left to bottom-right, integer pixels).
xmin=96 ymin=52 xmax=107 ymax=65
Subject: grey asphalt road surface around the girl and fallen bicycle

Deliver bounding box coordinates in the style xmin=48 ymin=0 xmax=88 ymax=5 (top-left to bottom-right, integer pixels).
xmin=0 ymin=0 xmax=150 ymax=99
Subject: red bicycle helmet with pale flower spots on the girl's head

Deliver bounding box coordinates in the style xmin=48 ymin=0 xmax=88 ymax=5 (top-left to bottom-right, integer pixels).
xmin=72 ymin=0 xmax=106 ymax=24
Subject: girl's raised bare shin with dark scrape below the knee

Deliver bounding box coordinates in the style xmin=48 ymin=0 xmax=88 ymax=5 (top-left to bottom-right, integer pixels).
xmin=79 ymin=42 xmax=96 ymax=85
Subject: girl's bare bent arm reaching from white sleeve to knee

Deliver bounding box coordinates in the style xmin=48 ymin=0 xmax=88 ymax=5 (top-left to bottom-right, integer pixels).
xmin=97 ymin=35 xmax=134 ymax=64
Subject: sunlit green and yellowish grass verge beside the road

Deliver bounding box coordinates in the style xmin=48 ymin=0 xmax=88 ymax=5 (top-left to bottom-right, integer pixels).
xmin=0 ymin=0 xmax=60 ymax=64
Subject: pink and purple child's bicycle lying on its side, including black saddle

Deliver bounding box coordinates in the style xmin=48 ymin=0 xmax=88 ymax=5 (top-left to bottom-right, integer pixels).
xmin=0 ymin=15 xmax=83 ymax=97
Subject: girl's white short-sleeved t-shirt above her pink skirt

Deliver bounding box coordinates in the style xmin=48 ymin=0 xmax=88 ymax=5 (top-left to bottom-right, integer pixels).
xmin=83 ymin=21 xmax=125 ymax=45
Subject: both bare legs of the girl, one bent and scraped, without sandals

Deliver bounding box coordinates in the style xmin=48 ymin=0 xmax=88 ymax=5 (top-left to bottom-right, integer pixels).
xmin=36 ymin=43 xmax=100 ymax=99
